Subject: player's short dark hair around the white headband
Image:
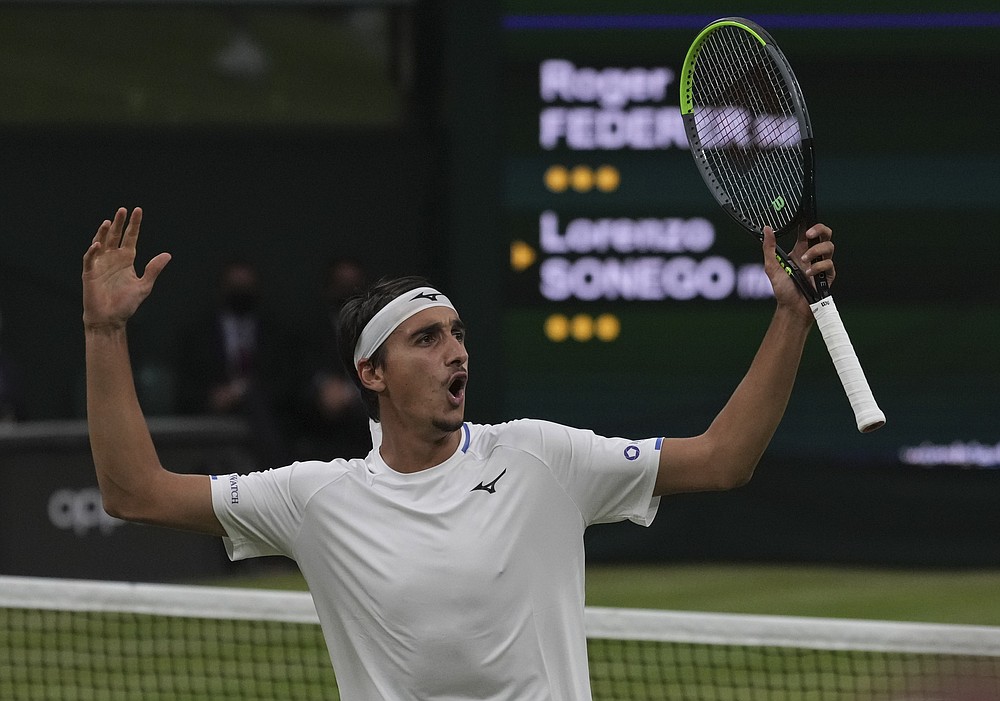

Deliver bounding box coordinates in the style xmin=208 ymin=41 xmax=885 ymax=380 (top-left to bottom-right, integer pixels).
xmin=338 ymin=275 xmax=431 ymax=421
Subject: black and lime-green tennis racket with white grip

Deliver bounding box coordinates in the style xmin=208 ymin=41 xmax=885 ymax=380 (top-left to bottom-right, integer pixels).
xmin=680 ymin=17 xmax=885 ymax=433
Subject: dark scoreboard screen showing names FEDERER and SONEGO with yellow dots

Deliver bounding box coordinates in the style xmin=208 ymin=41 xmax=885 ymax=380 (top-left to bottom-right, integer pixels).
xmin=498 ymin=5 xmax=1000 ymax=468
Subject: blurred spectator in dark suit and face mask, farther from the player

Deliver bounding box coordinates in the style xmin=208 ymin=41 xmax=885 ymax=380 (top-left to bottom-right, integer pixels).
xmin=177 ymin=261 xmax=300 ymax=469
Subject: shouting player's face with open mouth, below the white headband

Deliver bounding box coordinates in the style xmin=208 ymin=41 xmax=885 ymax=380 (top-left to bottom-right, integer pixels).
xmin=379 ymin=307 xmax=469 ymax=433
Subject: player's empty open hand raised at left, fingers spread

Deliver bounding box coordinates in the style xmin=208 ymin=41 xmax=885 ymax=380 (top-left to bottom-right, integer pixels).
xmin=83 ymin=207 xmax=170 ymax=328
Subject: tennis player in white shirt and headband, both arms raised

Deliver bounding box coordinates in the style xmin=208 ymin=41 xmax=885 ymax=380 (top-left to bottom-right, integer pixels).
xmin=83 ymin=208 xmax=834 ymax=701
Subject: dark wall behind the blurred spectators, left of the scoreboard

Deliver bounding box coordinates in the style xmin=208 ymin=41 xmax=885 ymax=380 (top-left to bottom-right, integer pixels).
xmin=0 ymin=129 xmax=436 ymax=419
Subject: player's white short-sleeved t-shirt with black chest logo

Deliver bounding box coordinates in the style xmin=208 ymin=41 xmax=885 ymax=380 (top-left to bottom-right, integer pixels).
xmin=212 ymin=420 xmax=661 ymax=701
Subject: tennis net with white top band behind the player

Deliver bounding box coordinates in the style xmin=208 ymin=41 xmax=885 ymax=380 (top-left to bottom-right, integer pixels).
xmin=0 ymin=577 xmax=1000 ymax=701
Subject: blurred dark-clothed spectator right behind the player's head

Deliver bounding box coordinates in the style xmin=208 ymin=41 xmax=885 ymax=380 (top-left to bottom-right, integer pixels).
xmin=296 ymin=258 xmax=371 ymax=460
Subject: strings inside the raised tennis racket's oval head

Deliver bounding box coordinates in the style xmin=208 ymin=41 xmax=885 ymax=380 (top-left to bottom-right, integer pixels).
xmin=692 ymin=27 xmax=805 ymax=229
